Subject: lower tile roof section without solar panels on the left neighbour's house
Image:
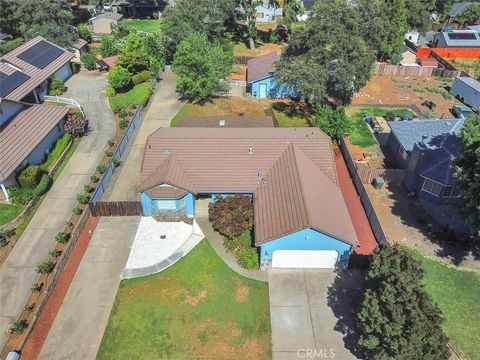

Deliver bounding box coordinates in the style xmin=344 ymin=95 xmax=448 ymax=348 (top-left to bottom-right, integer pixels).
xmin=0 ymin=105 xmax=68 ymax=180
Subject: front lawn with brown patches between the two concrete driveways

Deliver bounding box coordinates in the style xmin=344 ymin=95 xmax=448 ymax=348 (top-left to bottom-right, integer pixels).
xmin=97 ymin=240 xmax=271 ymax=360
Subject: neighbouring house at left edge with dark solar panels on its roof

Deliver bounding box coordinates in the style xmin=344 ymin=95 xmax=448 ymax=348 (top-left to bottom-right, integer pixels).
xmin=0 ymin=37 xmax=74 ymax=199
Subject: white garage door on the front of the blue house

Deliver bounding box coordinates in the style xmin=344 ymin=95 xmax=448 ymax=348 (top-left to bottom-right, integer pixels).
xmin=272 ymin=250 xmax=338 ymax=269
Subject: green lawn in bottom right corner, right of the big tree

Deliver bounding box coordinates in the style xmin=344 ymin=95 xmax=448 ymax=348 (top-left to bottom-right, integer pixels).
xmin=412 ymin=250 xmax=480 ymax=359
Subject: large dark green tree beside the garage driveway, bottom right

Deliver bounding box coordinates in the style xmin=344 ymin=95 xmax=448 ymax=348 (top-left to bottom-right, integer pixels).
xmin=357 ymin=245 xmax=450 ymax=360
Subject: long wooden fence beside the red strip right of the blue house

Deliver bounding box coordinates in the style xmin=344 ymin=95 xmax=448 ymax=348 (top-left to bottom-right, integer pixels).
xmin=340 ymin=139 xmax=387 ymax=244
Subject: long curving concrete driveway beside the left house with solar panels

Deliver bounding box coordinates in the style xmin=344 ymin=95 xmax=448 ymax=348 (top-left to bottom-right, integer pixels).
xmin=0 ymin=72 xmax=115 ymax=345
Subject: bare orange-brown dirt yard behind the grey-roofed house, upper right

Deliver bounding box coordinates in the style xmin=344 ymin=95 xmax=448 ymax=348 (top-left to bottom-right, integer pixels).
xmin=352 ymin=76 xmax=460 ymax=118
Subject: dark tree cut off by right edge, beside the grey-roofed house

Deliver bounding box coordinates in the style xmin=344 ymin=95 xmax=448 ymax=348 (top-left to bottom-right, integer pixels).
xmin=454 ymin=114 xmax=480 ymax=232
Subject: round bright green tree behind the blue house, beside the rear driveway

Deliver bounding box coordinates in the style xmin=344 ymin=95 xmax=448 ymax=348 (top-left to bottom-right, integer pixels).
xmin=173 ymin=33 xmax=232 ymax=100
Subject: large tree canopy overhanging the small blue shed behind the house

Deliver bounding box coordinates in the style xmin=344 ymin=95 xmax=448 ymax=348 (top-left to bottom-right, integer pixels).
xmin=275 ymin=0 xmax=375 ymax=103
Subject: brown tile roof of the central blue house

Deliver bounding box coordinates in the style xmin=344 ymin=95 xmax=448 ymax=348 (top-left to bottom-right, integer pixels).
xmin=138 ymin=128 xmax=357 ymax=244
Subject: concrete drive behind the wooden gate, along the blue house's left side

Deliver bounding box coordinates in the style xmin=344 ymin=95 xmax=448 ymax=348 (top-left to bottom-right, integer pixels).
xmin=110 ymin=71 xmax=183 ymax=201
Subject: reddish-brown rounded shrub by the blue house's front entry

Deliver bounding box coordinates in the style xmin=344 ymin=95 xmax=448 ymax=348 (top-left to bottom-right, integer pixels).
xmin=208 ymin=195 xmax=253 ymax=239
